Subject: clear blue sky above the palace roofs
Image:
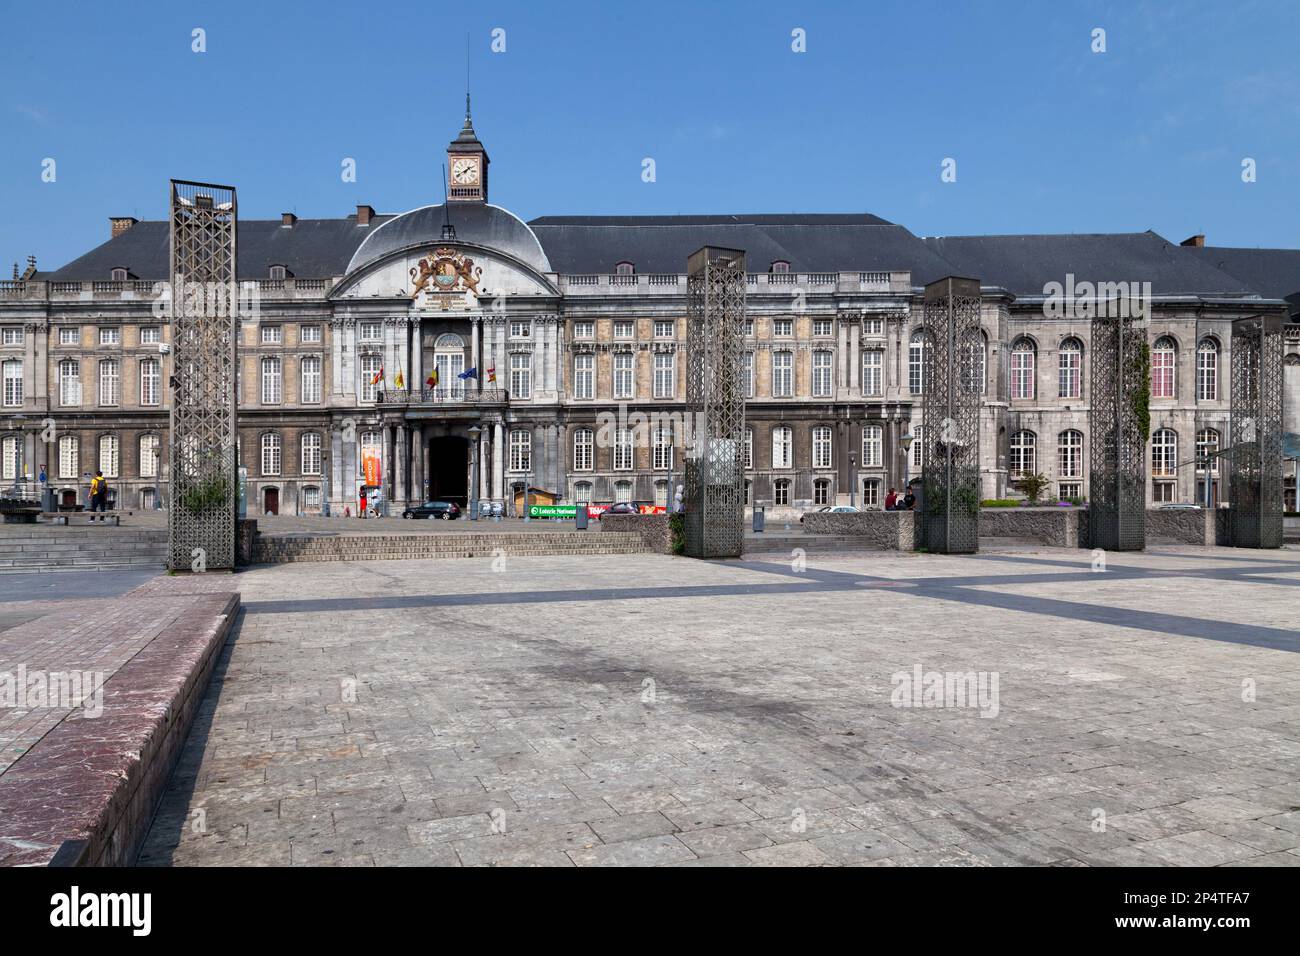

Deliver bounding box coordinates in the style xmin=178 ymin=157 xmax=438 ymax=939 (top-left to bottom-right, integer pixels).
xmin=0 ymin=0 xmax=1300 ymax=276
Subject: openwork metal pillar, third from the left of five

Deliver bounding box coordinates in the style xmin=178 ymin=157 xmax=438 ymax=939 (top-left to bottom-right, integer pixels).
xmin=920 ymin=276 xmax=984 ymax=554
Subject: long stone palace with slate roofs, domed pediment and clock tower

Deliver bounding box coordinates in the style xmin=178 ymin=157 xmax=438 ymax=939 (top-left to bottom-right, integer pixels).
xmin=0 ymin=116 xmax=1300 ymax=515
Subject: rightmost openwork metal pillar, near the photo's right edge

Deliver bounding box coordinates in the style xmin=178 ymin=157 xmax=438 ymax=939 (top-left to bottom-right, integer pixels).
xmin=1229 ymin=315 xmax=1283 ymax=548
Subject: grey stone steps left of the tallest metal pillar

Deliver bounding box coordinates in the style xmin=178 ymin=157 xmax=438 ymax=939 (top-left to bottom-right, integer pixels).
xmin=0 ymin=528 xmax=166 ymax=574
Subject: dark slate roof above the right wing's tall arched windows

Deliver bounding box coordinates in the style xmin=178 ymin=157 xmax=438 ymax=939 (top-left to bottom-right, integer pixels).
xmin=926 ymin=230 xmax=1257 ymax=297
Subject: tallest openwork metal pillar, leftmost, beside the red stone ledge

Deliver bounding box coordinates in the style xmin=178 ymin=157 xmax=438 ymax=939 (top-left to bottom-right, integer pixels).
xmin=168 ymin=179 xmax=239 ymax=571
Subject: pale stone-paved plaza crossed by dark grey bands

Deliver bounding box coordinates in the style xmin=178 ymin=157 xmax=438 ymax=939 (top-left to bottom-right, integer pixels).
xmin=134 ymin=548 xmax=1300 ymax=866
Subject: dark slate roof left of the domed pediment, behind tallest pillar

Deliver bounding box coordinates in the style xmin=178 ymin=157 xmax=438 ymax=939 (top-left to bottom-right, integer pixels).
xmin=44 ymin=216 xmax=391 ymax=282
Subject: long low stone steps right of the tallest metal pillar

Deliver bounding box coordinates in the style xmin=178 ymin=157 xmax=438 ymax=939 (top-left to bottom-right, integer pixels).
xmin=254 ymin=531 xmax=646 ymax=564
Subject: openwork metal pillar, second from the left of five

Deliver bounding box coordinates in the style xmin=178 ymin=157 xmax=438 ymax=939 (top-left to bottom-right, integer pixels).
xmin=686 ymin=246 xmax=745 ymax=558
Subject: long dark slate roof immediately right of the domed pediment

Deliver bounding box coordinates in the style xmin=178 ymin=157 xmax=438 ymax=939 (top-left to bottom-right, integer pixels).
xmin=529 ymin=213 xmax=952 ymax=282
